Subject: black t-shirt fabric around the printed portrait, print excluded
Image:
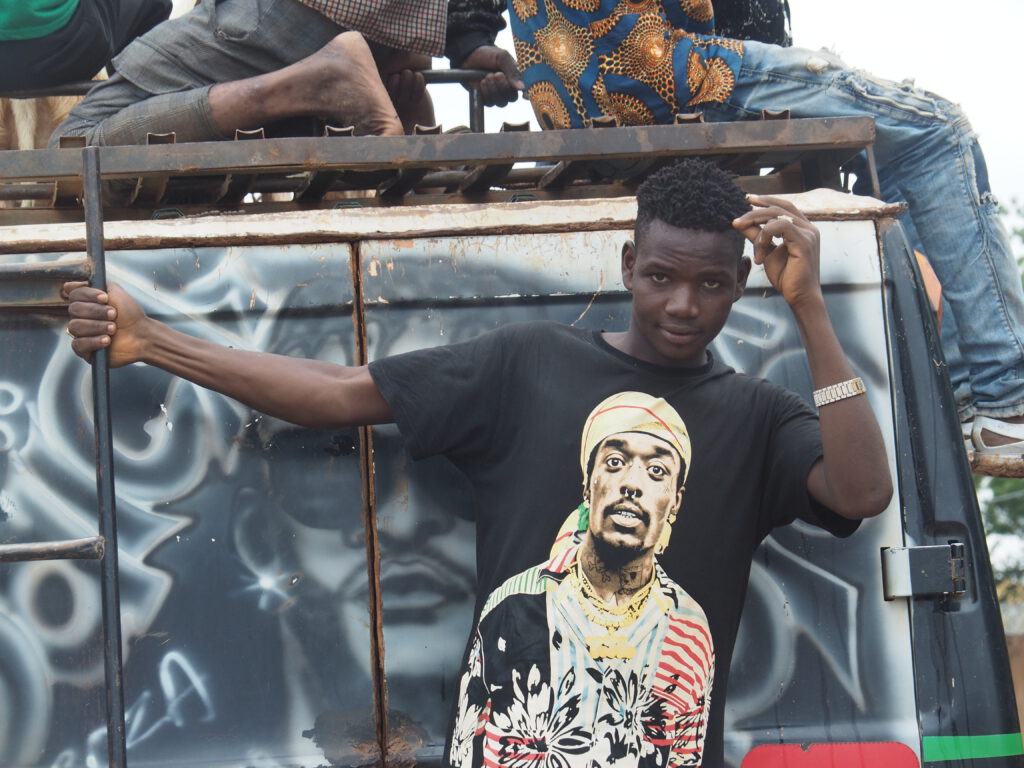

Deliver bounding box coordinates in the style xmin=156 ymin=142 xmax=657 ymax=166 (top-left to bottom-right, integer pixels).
xmin=370 ymin=323 xmax=856 ymax=766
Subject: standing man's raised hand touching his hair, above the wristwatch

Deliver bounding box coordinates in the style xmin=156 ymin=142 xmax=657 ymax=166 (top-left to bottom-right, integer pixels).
xmin=732 ymin=195 xmax=823 ymax=308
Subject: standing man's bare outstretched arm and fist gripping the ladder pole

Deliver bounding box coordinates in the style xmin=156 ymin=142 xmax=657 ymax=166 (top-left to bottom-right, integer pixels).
xmin=63 ymin=283 xmax=393 ymax=429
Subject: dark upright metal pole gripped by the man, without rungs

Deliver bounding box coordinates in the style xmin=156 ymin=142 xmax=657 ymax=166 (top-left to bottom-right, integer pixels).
xmin=82 ymin=146 xmax=128 ymax=768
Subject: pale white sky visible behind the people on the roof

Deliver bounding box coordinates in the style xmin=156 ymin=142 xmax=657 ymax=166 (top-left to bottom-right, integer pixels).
xmin=431 ymin=0 xmax=1024 ymax=217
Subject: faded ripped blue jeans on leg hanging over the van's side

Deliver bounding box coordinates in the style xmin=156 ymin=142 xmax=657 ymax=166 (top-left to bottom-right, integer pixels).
xmin=700 ymin=42 xmax=1024 ymax=419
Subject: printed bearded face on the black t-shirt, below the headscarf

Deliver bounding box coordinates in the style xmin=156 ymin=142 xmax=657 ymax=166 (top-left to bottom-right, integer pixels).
xmin=588 ymin=432 xmax=683 ymax=554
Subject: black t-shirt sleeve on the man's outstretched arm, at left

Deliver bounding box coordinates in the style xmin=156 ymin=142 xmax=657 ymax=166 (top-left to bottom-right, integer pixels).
xmin=370 ymin=331 xmax=512 ymax=465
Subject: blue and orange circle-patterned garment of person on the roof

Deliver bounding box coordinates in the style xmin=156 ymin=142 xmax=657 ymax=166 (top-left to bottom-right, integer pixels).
xmin=509 ymin=0 xmax=743 ymax=128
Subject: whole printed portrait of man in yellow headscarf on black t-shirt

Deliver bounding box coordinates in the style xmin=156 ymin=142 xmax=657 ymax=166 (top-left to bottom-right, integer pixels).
xmin=449 ymin=392 xmax=715 ymax=768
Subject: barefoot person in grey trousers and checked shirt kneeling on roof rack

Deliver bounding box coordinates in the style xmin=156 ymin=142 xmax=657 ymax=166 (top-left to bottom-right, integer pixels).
xmin=50 ymin=0 xmax=522 ymax=145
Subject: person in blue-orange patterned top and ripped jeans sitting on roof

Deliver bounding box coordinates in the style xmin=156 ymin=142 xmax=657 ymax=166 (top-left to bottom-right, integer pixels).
xmin=509 ymin=0 xmax=1024 ymax=476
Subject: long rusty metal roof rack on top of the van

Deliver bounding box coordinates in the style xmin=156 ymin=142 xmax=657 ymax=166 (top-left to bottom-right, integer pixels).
xmin=0 ymin=116 xmax=874 ymax=224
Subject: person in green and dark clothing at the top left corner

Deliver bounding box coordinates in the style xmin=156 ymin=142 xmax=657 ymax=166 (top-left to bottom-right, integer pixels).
xmin=0 ymin=0 xmax=171 ymax=92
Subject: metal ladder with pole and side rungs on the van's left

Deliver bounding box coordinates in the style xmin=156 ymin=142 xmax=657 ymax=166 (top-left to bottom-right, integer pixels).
xmin=0 ymin=146 xmax=127 ymax=768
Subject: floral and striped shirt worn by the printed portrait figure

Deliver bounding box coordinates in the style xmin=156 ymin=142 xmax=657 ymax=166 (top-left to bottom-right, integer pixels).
xmin=449 ymin=547 xmax=715 ymax=768
